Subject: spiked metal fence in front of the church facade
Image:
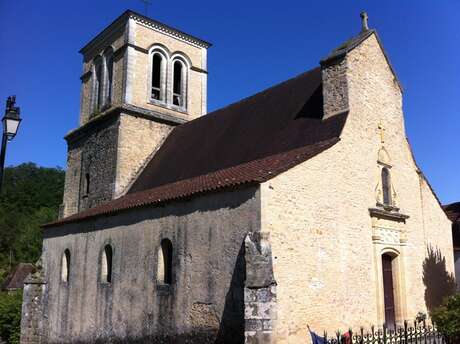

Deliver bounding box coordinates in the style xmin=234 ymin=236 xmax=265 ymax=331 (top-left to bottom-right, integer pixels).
xmin=323 ymin=321 xmax=446 ymax=344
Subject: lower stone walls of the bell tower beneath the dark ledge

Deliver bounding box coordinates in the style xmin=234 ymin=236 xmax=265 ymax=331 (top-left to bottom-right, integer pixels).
xmin=64 ymin=113 xmax=174 ymax=216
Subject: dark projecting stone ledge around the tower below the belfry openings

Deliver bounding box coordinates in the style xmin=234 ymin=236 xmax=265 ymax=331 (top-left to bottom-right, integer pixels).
xmin=64 ymin=104 xmax=187 ymax=143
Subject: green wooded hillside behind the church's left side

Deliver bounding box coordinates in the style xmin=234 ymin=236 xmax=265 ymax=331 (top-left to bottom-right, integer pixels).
xmin=0 ymin=163 xmax=64 ymax=283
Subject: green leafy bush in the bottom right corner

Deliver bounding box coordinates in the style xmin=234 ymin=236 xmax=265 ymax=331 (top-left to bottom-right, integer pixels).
xmin=431 ymin=293 xmax=460 ymax=343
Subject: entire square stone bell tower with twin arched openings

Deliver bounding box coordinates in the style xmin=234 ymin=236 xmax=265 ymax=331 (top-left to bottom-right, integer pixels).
xmin=61 ymin=11 xmax=210 ymax=217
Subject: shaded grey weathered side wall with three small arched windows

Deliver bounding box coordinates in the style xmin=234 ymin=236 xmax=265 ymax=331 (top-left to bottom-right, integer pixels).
xmin=43 ymin=186 xmax=260 ymax=344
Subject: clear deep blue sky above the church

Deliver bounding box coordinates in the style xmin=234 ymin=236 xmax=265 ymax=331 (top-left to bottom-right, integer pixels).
xmin=0 ymin=0 xmax=460 ymax=203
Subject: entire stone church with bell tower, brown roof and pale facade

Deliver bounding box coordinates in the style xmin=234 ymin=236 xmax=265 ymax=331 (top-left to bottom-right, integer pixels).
xmin=22 ymin=11 xmax=454 ymax=344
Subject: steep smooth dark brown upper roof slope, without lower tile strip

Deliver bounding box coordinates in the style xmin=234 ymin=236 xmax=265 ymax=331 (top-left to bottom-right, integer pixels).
xmin=129 ymin=68 xmax=346 ymax=193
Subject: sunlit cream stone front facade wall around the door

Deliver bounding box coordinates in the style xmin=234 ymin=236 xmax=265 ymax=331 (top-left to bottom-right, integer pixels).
xmin=261 ymin=31 xmax=453 ymax=344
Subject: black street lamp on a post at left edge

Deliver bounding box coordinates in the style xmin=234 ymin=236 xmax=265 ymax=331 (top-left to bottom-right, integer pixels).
xmin=0 ymin=96 xmax=21 ymax=192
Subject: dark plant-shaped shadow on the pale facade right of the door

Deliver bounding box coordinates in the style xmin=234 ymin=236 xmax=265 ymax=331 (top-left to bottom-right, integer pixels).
xmin=423 ymin=245 xmax=456 ymax=313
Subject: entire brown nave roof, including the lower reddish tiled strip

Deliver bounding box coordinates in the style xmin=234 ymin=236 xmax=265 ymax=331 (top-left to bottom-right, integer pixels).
xmin=44 ymin=68 xmax=347 ymax=227
